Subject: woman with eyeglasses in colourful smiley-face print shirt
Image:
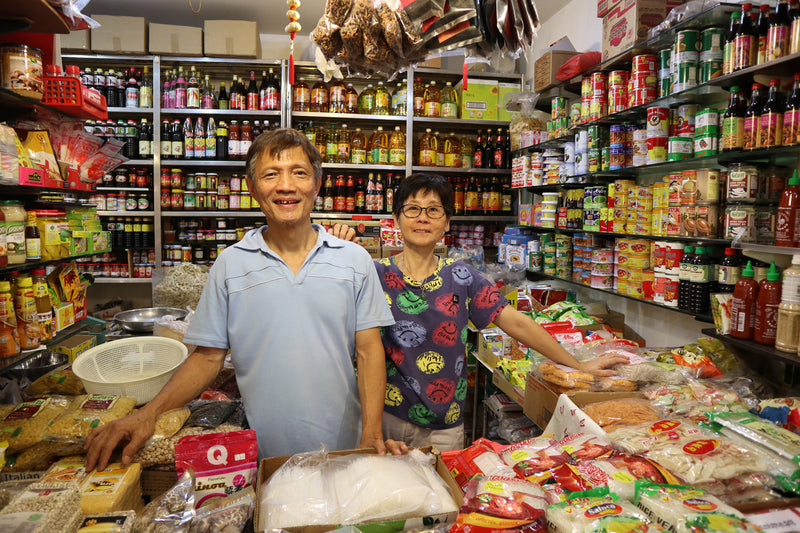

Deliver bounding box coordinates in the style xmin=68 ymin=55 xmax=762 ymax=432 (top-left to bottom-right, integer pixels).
xmin=332 ymin=173 xmax=628 ymax=451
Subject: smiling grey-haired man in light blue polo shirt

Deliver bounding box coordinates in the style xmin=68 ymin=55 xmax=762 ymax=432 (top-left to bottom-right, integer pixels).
xmin=86 ymin=129 xmax=406 ymax=469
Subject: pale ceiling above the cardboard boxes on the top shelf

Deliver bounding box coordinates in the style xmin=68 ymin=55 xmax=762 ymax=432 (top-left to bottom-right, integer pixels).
xmin=87 ymin=0 xmax=564 ymax=35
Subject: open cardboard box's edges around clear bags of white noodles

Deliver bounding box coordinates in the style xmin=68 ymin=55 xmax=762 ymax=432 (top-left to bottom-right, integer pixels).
xmin=253 ymin=447 xmax=464 ymax=533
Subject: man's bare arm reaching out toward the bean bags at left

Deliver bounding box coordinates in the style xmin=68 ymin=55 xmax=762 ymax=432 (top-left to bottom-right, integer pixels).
xmin=84 ymin=348 xmax=227 ymax=471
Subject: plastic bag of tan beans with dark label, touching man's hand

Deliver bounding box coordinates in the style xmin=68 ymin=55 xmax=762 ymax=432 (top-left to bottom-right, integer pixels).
xmin=47 ymin=394 xmax=136 ymax=440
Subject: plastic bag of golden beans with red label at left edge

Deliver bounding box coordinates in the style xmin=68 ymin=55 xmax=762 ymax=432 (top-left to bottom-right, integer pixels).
xmin=0 ymin=396 xmax=71 ymax=453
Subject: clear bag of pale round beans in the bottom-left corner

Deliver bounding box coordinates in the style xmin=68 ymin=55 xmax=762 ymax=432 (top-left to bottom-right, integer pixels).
xmin=0 ymin=483 xmax=82 ymax=533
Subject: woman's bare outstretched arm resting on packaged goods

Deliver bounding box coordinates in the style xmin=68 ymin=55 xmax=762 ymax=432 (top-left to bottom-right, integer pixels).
xmin=494 ymin=305 xmax=628 ymax=376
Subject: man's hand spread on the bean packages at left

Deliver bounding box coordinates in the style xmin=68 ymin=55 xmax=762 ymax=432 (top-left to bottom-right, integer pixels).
xmin=84 ymin=409 xmax=156 ymax=471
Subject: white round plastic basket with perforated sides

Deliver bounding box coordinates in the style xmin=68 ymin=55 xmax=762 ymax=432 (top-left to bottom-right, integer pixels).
xmin=72 ymin=337 xmax=188 ymax=405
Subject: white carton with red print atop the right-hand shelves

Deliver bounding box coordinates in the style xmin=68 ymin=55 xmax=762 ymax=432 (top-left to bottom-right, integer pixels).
xmin=604 ymin=0 xmax=683 ymax=60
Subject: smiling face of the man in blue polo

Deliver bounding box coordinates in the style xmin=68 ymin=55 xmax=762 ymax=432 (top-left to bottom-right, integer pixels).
xmin=252 ymin=146 xmax=321 ymax=226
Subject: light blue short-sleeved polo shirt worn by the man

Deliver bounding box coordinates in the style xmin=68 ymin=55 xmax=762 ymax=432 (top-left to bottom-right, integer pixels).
xmin=184 ymin=224 xmax=394 ymax=457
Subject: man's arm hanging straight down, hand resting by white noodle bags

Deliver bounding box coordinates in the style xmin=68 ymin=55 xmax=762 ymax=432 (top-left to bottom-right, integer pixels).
xmin=356 ymin=328 xmax=408 ymax=455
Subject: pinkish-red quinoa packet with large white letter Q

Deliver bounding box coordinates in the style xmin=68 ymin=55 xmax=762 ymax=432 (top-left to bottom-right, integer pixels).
xmin=175 ymin=429 xmax=258 ymax=507
